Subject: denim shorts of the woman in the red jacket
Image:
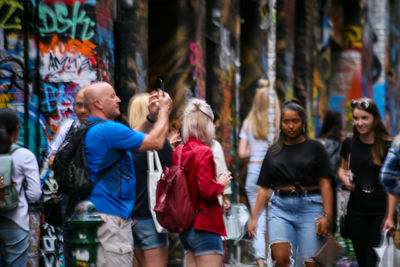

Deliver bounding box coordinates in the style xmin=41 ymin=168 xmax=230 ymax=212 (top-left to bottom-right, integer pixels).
xmin=179 ymin=227 xmax=224 ymax=256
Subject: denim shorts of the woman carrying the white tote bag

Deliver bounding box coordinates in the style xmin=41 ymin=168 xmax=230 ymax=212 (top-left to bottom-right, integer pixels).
xmin=132 ymin=218 xmax=168 ymax=250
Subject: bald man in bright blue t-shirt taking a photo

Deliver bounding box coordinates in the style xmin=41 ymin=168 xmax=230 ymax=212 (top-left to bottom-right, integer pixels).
xmin=84 ymin=82 xmax=172 ymax=267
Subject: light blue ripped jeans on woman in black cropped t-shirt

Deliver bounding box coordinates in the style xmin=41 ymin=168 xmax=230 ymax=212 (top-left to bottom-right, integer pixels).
xmin=268 ymin=194 xmax=325 ymax=266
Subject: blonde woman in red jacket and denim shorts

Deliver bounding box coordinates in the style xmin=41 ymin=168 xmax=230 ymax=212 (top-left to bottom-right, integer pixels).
xmin=178 ymin=98 xmax=232 ymax=267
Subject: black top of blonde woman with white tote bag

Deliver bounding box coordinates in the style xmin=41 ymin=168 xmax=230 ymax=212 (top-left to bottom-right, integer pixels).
xmin=132 ymin=140 xmax=172 ymax=218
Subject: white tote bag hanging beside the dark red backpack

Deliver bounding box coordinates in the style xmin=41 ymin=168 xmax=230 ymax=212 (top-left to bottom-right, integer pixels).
xmin=147 ymin=151 xmax=167 ymax=233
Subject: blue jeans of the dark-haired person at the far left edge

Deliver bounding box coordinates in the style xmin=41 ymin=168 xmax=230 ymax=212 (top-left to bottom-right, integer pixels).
xmin=0 ymin=228 xmax=29 ymax=267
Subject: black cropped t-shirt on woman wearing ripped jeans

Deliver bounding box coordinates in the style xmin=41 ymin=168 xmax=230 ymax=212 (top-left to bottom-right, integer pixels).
xmin=257 ymin=139 xmax=332 ymax=188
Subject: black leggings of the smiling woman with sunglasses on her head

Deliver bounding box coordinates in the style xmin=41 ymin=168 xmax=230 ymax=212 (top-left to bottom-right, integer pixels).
xmin=348 ymin=192 xmax=386 ymax=267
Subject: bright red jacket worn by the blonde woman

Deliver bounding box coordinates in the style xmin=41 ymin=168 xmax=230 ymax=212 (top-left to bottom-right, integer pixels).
xmin=172 ymin=137 xmax=226 ymax=236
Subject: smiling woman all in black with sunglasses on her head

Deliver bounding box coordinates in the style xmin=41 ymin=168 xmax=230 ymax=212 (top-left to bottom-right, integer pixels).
xmin=338 ymin=98 xmax=394 ymax=267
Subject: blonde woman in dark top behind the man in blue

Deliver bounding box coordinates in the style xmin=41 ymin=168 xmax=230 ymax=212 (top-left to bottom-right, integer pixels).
xmin=128 ymin=93 xmax=172 ymax=267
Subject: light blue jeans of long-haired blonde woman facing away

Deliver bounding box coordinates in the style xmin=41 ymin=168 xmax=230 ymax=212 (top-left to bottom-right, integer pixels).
xmin=246 ymin=163 xmax=267 ymax=259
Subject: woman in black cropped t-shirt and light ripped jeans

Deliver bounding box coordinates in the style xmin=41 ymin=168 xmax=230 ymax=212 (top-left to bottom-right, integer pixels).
xmin=248 ymin=100 xmax=333 ymax=266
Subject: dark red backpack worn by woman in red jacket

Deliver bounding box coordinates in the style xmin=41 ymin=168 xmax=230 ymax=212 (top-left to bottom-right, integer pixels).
xmin=154 ymin=146 xmax=195 ymax=233
